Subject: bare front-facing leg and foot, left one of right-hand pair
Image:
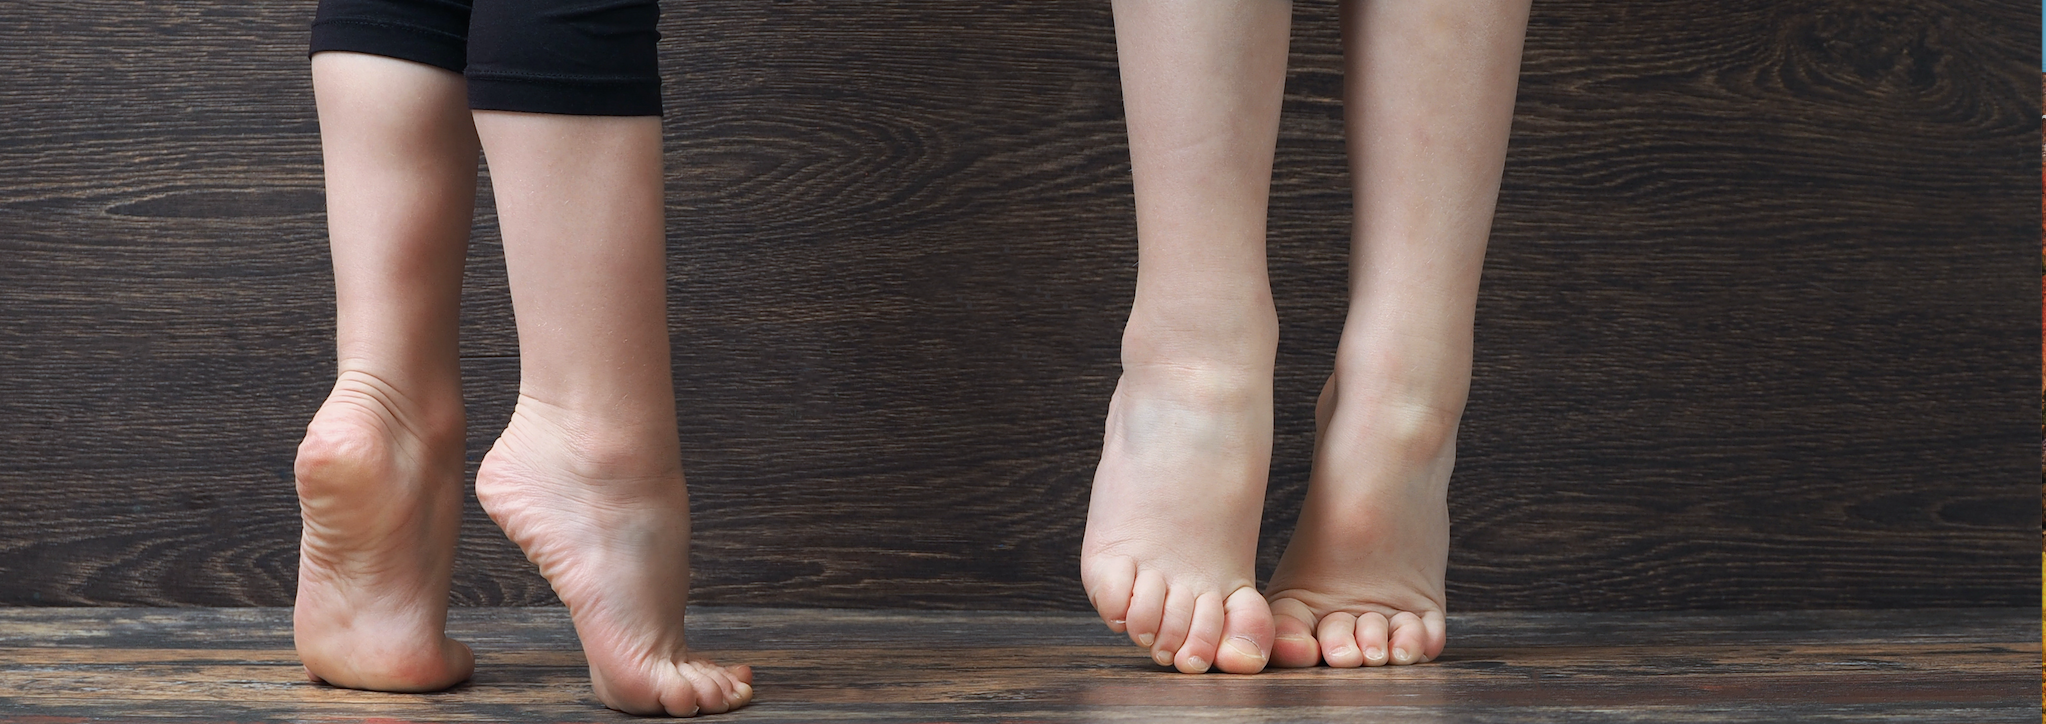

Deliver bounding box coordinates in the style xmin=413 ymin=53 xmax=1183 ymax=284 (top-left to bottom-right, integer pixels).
xmin=1080 ymin=0 xmax=1291 ymax=673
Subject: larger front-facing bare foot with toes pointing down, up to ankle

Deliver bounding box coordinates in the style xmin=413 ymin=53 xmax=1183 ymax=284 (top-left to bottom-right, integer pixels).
xmin=1080 ymin=366 xmax=1273 ymax=673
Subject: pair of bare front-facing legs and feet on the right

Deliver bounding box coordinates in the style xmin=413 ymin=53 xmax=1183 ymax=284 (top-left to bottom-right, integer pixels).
xmin=1082 ymin=0 xmax=1528 ymax=671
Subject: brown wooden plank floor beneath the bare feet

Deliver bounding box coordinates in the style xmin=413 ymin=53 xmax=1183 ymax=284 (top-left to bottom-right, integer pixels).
xmin=0 ymin=607 xmax=2040 ymax=724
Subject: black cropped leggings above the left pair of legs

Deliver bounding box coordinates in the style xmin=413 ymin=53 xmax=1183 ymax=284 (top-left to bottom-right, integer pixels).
xmin=307 ymin=0 xmax=661 ymax=117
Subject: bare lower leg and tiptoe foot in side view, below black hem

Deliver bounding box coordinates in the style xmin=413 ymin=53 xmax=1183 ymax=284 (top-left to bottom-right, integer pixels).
xmin=475 ymin=110 xmax=753 ymax=716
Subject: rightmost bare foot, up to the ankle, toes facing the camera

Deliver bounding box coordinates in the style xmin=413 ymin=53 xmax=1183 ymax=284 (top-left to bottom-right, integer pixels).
xmin=1266 ymin=376 xmax=1461 ymax=667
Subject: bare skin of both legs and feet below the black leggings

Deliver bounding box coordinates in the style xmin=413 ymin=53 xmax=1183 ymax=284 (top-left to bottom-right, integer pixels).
xmin=297 ymin=53 xmax=753 ymax=716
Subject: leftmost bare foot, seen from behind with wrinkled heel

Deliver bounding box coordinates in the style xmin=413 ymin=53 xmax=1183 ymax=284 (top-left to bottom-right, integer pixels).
xmin=293 ymin=370 xmax=475 ymax=691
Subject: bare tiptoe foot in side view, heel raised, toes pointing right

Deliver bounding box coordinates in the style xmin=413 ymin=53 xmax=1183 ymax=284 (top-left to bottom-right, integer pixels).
xmin=477 ymin=397 xmax=753 ymax=716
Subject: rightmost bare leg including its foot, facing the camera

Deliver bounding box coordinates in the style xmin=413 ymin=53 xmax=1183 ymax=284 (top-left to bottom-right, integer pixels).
xmin=1269 ymin=0 xmax=1528 ymax=667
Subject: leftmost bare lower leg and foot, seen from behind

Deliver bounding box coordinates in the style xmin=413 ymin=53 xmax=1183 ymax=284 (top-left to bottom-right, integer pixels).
xmin=293 ymin=53 xmax=477 ymax=691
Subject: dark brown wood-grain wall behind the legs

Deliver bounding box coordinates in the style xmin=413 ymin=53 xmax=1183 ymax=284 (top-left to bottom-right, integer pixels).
xmin=0 ymin=0 xmax=2040 ymax=609
